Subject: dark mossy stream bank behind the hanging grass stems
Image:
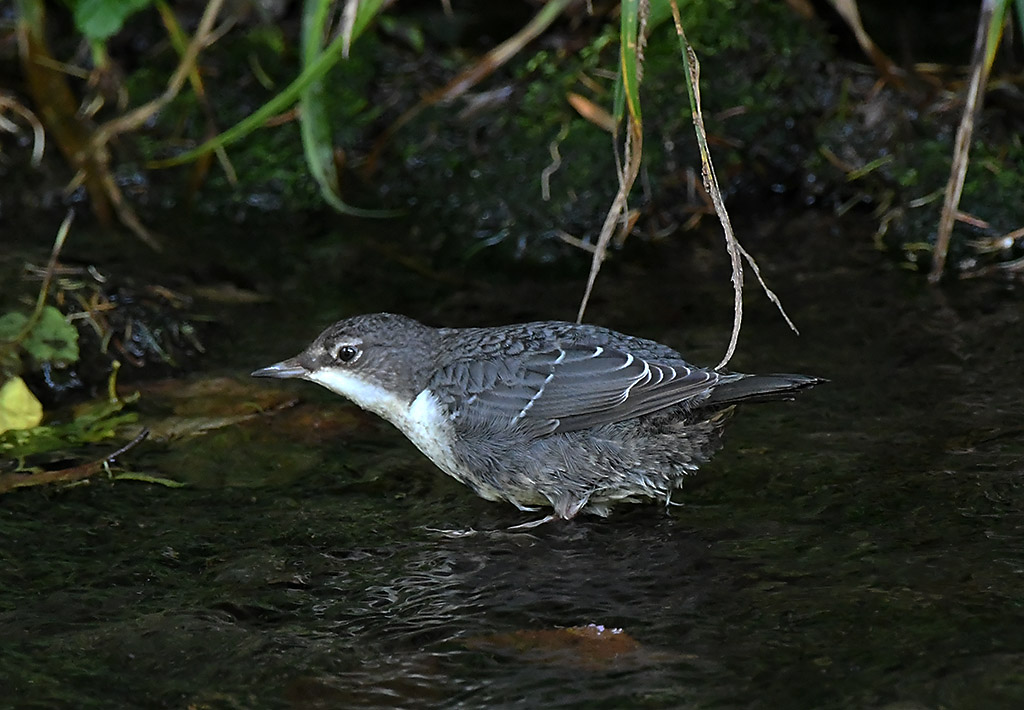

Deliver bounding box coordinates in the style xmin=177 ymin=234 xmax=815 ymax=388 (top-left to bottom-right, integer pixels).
xmin=99 ymin=1 xmax=1024 ymax=267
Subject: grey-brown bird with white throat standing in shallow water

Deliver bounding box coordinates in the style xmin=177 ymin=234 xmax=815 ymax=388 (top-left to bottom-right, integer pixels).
xmin=252 ymin=314 xmax=823 ymax=527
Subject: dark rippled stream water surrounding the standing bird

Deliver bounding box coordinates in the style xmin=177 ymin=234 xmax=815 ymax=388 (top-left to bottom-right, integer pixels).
xmin=0 ymin=207 xmax=1024 ymax=710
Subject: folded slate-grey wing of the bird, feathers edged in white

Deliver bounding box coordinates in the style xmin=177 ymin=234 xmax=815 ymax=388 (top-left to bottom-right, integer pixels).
xmin=434 ymin=345 xmax=719 ymax=436
